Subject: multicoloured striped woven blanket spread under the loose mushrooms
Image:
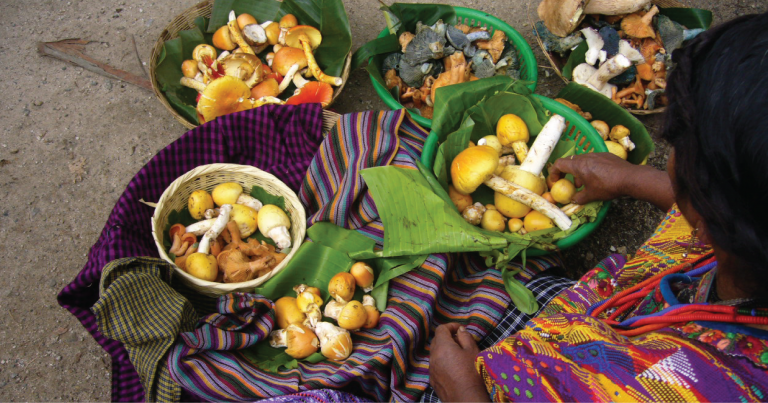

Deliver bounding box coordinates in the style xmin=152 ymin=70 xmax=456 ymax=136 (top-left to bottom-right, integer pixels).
xmin=169 ymin=110 xmax=554 ymax=402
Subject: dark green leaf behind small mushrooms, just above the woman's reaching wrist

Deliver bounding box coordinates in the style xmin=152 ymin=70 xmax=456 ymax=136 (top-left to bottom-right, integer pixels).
xmin=557 ymin=83 xmax=656 ymax=164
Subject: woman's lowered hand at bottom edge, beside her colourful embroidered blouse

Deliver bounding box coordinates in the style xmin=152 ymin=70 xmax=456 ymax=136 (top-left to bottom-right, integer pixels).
xmin=429 ymin=323 xmax=490 ymax=403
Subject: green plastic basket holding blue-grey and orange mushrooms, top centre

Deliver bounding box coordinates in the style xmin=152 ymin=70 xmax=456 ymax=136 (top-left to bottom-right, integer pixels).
xmin=371 ymin=7 xmax=538 ymax=129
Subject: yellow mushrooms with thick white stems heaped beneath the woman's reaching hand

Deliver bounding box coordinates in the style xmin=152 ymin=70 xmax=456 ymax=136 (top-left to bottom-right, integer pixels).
xmin=448 ymin=114 xmax=604 ymax=234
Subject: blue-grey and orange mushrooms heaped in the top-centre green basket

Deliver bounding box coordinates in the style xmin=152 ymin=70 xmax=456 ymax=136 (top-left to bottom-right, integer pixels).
xmin=381 ymin=20 xmax=520 ymax=119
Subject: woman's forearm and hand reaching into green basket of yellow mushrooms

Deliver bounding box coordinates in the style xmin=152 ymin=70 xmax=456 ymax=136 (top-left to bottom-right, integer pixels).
xmin=549 ymin=153 xmax=675 ymax=211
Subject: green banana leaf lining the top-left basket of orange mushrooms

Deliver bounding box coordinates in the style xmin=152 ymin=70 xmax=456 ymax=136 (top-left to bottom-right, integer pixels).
xmin=155 ymin=0 xmax=352 ymax=124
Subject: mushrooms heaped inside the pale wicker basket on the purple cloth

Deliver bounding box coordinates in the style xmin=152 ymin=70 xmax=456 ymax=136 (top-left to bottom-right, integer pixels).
xmin=168 ymin=182 xmax=291 ymax=283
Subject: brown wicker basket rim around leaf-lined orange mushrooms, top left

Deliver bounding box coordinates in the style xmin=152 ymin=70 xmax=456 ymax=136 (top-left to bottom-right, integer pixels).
xmin=149 ymin=0 xmax=352 ymax=129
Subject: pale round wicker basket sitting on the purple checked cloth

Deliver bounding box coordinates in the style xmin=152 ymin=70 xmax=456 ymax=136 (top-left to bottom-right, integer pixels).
xmin=152 ymin=164 xmax=307 ymax=297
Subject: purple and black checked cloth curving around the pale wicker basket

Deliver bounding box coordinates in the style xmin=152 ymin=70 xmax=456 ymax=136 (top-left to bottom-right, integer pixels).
xmin=58 ymin=104 xmax=323 ymax=402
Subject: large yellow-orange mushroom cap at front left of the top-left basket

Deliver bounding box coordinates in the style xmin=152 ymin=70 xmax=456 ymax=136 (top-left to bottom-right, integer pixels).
xmin=197 ymin=76 xmax=251 ymax=122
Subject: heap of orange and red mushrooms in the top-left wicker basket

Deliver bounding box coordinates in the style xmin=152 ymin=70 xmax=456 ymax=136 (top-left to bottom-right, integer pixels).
xmin=181 ymin=11 xmax=342 ymax=124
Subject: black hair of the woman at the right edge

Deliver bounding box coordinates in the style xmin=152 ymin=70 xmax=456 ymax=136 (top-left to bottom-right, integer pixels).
xmin=662 ymin=13 xmax=768 ymax=298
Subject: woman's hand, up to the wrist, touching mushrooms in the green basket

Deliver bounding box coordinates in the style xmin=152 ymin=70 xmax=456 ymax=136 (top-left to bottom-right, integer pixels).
xmin=549 ymin=153 xmax=636 ymax=204
